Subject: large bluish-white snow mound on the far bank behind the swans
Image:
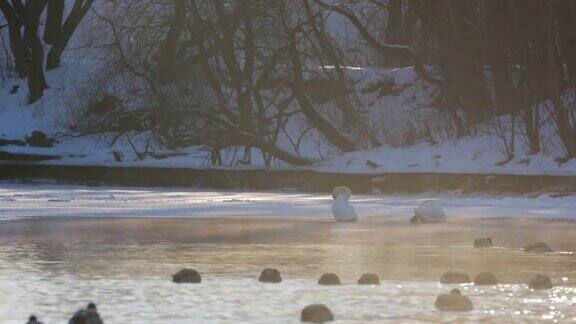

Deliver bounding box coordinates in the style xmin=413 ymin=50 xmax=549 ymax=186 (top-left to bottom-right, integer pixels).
xmin=315 ymin=135 xmax=576 ymax=176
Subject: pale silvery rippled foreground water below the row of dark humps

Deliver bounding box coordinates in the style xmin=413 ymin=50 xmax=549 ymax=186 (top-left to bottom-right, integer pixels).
xmin=0 ymin=277 xmax=576 ymax=323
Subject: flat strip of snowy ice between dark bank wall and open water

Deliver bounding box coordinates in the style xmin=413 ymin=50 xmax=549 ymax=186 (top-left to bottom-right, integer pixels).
xmin=0 ymin=183 xmax=576 ymax=220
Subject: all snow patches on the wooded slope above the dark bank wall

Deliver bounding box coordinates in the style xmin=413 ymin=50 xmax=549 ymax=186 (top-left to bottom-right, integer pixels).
xmin=0 ymin=57 xmax=576 ymax=176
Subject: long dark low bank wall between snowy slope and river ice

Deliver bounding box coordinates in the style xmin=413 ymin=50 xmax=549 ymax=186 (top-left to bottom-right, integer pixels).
xmin=0 ymin=163 xmax=576 ymax=196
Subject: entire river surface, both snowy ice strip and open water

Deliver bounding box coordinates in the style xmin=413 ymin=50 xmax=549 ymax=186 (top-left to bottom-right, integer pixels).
xmin=0 ymin=184 xmax=576 ymax=324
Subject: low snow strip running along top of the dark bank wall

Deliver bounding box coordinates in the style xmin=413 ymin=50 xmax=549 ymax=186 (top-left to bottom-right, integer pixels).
xmin=0 ymin=136 xmax=576 ymax=176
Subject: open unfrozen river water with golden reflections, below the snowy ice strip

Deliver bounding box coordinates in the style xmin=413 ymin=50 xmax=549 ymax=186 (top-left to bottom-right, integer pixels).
xmin=0 ymin=218 xmax=576 ymax=323
